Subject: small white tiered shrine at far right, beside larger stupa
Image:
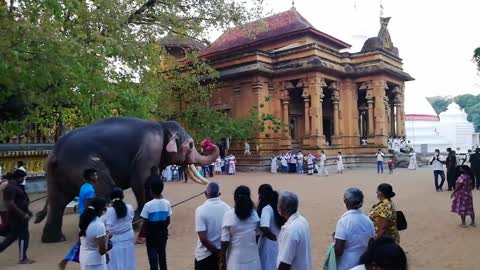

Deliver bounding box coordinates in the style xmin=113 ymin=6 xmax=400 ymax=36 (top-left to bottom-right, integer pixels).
xmin=439 ymin=102 xmax=475 ymax=153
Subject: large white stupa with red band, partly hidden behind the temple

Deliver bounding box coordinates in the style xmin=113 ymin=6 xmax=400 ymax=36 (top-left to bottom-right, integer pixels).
xmin=405 ymin=96 xmax=451 ymax=153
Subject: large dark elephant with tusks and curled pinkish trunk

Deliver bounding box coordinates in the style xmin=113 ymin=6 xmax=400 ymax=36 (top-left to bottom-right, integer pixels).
xmin=35 ymin=117 xmax=219 ymax=243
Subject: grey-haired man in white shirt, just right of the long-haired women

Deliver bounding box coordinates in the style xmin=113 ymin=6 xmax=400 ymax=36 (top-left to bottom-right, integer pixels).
xmin=277 ymin=192 xmax=312 ymax=270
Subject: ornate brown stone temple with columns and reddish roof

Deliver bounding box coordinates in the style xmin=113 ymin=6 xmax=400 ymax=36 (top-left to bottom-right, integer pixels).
xmin=201 ymin=8 xmax=413 ymax=156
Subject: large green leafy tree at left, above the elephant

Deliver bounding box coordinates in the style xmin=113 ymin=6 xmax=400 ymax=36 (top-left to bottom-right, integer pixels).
xmin=0 ymin=0 xmax=262 ymax=140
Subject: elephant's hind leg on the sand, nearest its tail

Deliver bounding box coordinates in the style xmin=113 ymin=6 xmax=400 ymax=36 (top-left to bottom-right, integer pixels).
xmin=42 ymin=186 xmax=75 ymax=243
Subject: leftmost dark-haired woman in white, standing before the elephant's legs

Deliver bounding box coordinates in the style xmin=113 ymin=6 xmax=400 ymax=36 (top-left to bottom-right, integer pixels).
xmin=78 ymin=198 xmax=111 ymax=270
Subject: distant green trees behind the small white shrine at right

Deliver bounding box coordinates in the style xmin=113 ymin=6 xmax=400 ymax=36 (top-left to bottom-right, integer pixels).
xmin=428 ymin=94 xmax=480 ymax=132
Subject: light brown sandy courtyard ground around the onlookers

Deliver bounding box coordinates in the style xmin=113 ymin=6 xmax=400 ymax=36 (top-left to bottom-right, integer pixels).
xmin=0 ymin=168 xmax=480 ymax=270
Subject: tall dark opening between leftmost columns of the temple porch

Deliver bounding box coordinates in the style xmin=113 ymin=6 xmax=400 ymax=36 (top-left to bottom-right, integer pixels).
xmin=288 ymin=88 xmax=305 ymax=150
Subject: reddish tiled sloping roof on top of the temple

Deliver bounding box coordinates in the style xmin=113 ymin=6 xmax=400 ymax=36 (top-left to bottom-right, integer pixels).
xmin=202 ymin=8 xmax=350 ymax=56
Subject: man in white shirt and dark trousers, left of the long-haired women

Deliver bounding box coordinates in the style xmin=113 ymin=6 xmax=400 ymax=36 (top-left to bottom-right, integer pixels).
xmin=195 ymin=182 xmax=230 ymax=270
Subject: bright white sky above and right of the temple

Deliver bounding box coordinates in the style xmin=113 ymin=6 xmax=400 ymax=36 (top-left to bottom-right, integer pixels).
xmin=212 ymin=0 xmax=480 ymax=99
